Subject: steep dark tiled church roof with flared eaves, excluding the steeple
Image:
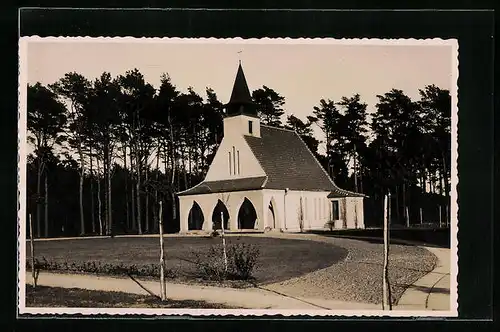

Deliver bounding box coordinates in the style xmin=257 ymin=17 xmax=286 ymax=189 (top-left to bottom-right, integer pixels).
xmin=179 ymin=125 xmax=365 ymax=198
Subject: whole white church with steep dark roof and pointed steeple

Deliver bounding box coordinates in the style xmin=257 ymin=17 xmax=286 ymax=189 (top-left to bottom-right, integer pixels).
xmin=177 ymin=63 xmax=365 ymax=233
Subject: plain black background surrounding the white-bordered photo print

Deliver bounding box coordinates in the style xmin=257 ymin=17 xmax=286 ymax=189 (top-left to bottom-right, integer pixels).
xmin=0 ymin=1 xmax=498 ymax=331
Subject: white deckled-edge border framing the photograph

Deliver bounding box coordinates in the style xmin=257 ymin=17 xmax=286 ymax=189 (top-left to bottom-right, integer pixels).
xmin=17 ymin=35 xmax=459 ymax=318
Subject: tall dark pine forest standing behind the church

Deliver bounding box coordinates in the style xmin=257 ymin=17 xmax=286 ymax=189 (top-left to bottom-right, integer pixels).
xmin=27 ymin=69 xmax=451 ymax=237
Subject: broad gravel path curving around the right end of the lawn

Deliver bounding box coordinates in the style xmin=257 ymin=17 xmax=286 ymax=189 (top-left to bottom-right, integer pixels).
xmin=262 ymin=234 xmax=437 ymax=304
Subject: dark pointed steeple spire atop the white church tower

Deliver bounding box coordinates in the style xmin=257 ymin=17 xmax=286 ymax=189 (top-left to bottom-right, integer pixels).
xmin=225 ymin=61 xmax=257 ymax=117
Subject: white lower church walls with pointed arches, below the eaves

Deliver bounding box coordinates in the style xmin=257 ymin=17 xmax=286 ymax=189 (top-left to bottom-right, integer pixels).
xmin=179 ymin=189 xmax=364 ymax=232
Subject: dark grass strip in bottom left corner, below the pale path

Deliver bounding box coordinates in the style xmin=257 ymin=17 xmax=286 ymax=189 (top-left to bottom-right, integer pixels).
xmin=26 ymin=285 xmax=237 ymax=309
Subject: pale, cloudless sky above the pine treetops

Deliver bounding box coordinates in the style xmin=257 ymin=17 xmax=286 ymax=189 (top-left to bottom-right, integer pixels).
xmin=27 ymin=39 xmax=454 ymax=152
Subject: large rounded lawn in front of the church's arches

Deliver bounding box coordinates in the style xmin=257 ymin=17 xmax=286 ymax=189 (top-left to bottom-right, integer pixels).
xmin=27 ymin=236 xmax=347 ymax=284
